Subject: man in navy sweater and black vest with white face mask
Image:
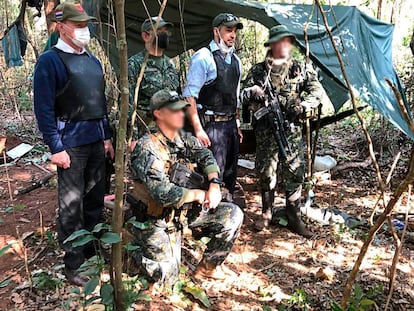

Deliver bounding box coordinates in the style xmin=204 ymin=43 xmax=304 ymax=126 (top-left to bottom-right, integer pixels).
xmin=33 ymin=2 xmax=114 ymax=286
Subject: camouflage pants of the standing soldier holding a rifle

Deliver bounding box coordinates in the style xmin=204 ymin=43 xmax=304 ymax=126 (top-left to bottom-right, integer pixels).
xmin=255 ymin=122 xmax=305 ymax=192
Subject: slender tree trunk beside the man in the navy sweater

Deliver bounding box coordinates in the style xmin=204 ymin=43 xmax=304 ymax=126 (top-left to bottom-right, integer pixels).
xmin=111 ymin=0 xmax=129 ymax=311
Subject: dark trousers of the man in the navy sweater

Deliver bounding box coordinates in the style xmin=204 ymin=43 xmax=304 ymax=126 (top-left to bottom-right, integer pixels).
xmin=57 ymin=141 xmax=105 ymax=270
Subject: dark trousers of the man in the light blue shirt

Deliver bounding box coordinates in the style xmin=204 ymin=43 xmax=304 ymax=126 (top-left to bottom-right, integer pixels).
xmin=205 ymin=120 xmax=240 ymax=193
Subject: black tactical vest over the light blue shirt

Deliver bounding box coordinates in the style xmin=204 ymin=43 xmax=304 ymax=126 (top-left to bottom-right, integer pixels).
xmin=197 ymin=50 xmax=240 ymax=115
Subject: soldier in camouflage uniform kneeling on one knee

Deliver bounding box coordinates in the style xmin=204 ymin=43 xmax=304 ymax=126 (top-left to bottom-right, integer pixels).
xmin=131 ymin=90 xmax=243 ymax=285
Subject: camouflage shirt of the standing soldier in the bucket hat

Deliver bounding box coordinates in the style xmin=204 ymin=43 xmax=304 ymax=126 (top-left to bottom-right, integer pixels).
xmin=242 ymin=53 xmax=323 ymax=119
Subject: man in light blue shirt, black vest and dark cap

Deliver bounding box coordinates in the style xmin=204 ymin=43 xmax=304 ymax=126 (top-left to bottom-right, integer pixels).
xmin=183 ymin=13 xmax=243 ymax=199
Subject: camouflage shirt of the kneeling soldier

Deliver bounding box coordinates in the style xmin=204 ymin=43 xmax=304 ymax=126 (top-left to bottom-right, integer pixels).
xmin=131 ymin=129 xmax=219 ymax=208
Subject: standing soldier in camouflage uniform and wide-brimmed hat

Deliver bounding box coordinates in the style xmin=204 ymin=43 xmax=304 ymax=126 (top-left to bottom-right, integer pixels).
xmin=242 ymin=25 xmax=323 ymax=237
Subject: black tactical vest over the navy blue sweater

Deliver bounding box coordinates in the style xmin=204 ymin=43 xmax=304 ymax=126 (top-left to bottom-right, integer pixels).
xmin=53 ymin=48 xmax=106 ymax=121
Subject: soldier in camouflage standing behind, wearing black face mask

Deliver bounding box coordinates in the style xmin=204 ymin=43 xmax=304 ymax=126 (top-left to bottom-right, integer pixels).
xmin=128 ymin=17 xmax=180 ymax=145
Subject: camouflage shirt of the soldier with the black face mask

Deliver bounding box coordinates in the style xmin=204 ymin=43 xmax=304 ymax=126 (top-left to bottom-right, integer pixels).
xmin=128 ymin=50 xmax=180 ymax=140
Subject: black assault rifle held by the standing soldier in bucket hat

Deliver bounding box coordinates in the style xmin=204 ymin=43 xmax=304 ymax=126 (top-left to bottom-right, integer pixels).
xmin=254 ymin=92 xmax=290 ymax=159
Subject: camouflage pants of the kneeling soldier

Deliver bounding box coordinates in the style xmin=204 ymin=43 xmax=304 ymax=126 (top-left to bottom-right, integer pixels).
xmin=133 ymin=202 xmax=243 ymax=285
